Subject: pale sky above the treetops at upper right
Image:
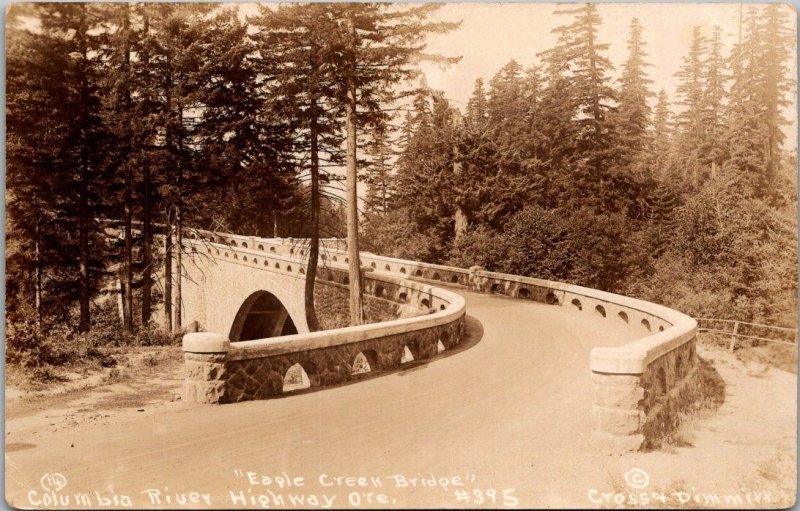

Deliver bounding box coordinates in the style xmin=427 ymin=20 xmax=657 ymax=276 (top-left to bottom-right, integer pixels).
xmin=423 ymin=3 xmax=797 ymax=147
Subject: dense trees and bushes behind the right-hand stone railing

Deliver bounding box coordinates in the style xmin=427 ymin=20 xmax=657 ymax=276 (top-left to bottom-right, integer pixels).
xmin=367 ymin=4 xmax=797 ymax=325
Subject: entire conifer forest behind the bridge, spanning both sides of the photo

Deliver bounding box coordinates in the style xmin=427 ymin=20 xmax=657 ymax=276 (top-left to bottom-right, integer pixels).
xmin=6 ymin=3 xmax=797 ymax=376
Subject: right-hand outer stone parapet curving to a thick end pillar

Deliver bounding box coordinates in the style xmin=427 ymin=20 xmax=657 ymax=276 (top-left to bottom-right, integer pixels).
xmin=304 ymin=246 xmax=697 ymax=453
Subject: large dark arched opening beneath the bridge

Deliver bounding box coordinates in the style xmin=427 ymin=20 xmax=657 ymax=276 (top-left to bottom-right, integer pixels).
xmin=229 ymin=291 xmax=297 ymax=342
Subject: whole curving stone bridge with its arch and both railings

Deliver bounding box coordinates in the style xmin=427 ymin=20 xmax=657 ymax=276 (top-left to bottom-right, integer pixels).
xmin=177 ymin=231 xmax=697 ymax=452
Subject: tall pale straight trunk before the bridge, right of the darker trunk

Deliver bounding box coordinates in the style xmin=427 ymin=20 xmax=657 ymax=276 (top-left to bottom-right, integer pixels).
xmin=345 ymin=17 xmax=364 ymax=326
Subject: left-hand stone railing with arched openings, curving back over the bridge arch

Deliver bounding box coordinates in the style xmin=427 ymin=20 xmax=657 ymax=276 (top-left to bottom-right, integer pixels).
xmin=183 ymin=236 xmax=465 ymax=403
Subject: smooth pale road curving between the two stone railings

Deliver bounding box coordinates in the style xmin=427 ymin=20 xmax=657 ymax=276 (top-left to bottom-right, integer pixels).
xmin=6 ymin=289 xmax=644 ymax=509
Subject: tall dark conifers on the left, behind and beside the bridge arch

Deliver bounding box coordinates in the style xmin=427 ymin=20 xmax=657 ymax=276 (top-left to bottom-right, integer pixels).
xmin=6 ymin=3 xmax=458 ymax=368
